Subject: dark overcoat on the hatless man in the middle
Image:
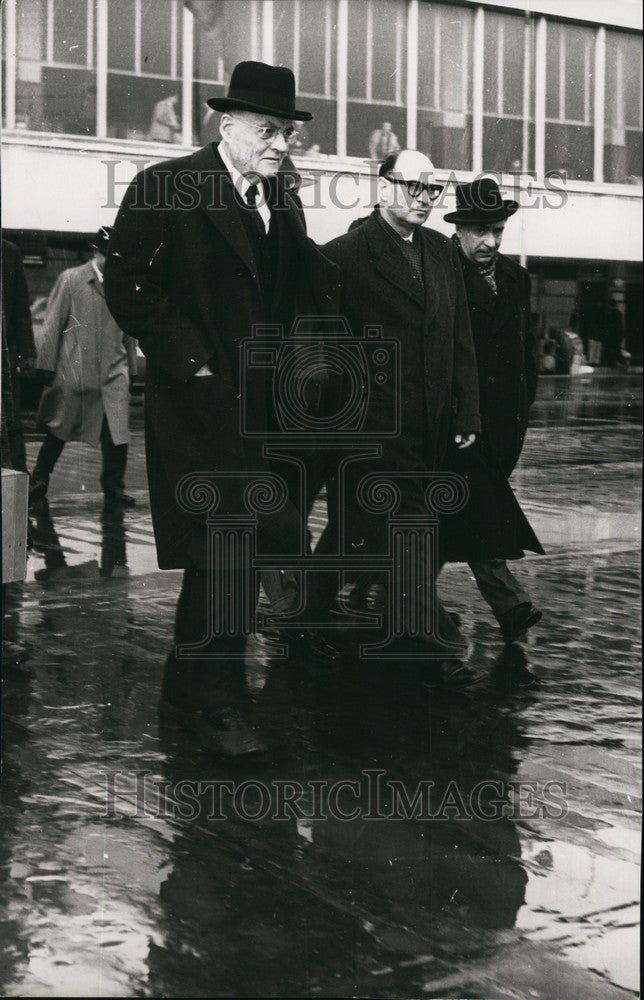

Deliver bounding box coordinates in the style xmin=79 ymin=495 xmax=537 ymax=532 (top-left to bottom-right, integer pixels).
xmin=316 ymin=210 xmax=480 ymax=568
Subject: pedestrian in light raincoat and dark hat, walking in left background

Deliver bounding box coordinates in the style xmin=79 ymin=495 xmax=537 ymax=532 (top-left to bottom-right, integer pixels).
xmin=30 ymin=226 xmax=136 ymax=507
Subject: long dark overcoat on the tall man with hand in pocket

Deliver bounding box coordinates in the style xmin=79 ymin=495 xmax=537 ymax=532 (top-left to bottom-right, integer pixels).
xmin=105 ymin=139 xmax=338 ymax=569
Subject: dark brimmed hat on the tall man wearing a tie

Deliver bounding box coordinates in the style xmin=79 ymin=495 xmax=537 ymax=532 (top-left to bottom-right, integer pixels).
xmin=206 ymin=62 xmax=313 ymax=122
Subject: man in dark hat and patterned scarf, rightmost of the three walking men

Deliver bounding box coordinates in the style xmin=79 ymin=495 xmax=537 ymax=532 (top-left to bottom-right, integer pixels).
xmin=440 ymin=177 xmax=543 ymax=643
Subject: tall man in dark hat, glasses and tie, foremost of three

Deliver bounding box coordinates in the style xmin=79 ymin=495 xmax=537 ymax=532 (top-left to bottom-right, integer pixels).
xmin=105 ymin=62 xmax=338 ymax=757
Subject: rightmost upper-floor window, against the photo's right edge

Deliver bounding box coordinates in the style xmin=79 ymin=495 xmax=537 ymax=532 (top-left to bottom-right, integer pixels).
xmin=604 ymin=31 xmax=642 ymax=184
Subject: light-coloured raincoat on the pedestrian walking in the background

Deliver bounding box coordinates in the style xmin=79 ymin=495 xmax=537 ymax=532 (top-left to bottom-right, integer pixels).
xmin=37 ymin=261 xmax=136 ymax=447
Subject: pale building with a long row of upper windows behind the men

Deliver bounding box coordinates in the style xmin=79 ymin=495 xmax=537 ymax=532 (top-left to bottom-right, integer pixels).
xmin=2 ymin=0 xmax=642 ymax=357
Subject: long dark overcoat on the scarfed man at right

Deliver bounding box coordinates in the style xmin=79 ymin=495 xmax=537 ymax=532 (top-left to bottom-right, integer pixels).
xmin=440 ymin=238 xmax=543 ymax=562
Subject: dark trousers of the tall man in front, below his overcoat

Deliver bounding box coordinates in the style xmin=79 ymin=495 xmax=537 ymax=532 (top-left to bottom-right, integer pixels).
xmin=162 ymin=568 xmax=254 ymax=712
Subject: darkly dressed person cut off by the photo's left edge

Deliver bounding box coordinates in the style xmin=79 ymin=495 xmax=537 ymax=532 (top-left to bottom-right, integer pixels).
xmin=2 ymin=240 xmax=36 ymax=472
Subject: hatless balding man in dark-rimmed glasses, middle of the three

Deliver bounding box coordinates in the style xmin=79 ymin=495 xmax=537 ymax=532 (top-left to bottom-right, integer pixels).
xmin=319 ymin=150 xmax=480 ymax=670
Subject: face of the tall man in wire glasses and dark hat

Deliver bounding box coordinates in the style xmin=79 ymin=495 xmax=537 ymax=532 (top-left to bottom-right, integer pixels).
xmin=221 ymin=111 xmax=297 ymax=177
